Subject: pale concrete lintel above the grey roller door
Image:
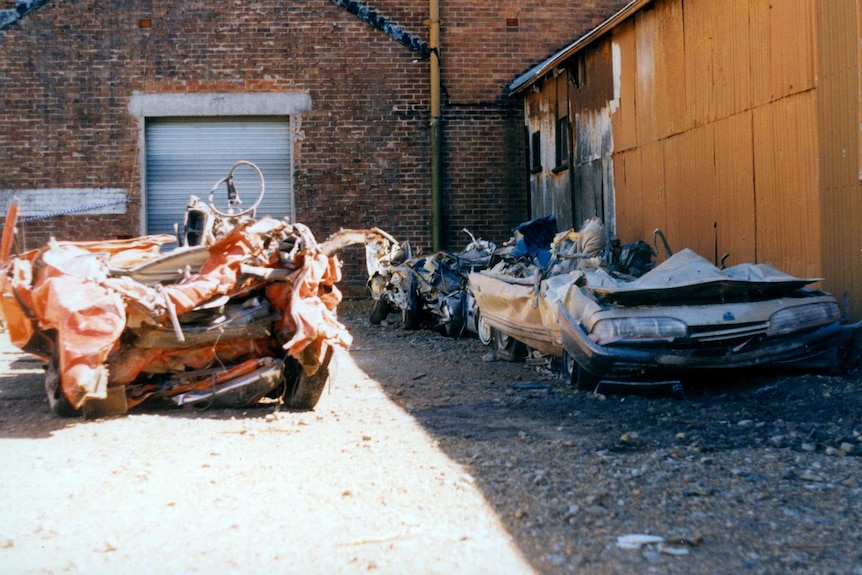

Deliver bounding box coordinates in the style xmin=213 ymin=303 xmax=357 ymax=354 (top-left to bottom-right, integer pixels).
xmin=129 ymin=92 xmax=311 ymax=118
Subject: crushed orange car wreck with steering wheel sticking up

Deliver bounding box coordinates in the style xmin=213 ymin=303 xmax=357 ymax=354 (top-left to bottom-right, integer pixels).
xmin=0 ymin=161 xmax=382 ymax=417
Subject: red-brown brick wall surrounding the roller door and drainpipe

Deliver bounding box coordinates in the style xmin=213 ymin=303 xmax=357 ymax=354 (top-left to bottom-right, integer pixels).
xmin=0 ymin=0 xmax=625 ymax=284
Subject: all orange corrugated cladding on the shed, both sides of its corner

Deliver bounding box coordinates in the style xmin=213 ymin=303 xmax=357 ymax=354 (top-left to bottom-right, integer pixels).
xmin=612 ymin=0 xmax=862 ymax=319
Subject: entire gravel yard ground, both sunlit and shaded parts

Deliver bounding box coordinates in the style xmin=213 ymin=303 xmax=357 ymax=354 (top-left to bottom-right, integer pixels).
xmin=0 ymin=300 xmax=862 ymax=575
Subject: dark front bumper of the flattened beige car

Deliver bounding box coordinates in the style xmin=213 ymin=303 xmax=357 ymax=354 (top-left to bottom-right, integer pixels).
xmin=559 ymin=305 xmax=845 ymax=381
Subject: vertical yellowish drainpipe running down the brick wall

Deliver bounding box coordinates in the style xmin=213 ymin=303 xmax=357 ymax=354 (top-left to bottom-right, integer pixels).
xmin=428 ymin=0 xmax=443 ymax=252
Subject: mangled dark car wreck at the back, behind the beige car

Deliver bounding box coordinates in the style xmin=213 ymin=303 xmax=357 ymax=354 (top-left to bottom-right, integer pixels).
xmin=365 ymin=229 xmax=496 ymax=343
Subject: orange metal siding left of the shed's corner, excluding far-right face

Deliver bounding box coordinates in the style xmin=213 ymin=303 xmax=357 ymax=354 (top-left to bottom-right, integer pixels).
xmin=612 ymin=0 xmax=828 ymax=275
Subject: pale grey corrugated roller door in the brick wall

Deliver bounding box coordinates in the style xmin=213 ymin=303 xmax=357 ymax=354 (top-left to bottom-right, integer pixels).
xmin=146 ymin=116 xmax=295 ymax=234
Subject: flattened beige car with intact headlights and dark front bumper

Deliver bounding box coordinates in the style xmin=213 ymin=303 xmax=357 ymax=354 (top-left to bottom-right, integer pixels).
xmin=469 ymin=219 xmax=847 ymax=390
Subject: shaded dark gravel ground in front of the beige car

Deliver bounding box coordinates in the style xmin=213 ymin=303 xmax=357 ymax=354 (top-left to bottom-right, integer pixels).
xmin=340 ymin=302 xmax=862 ymax=574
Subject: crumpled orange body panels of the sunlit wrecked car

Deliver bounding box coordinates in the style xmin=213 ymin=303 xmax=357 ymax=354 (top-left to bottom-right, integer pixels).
xmin=0 ymin=217 xmax=351 ymax=408
